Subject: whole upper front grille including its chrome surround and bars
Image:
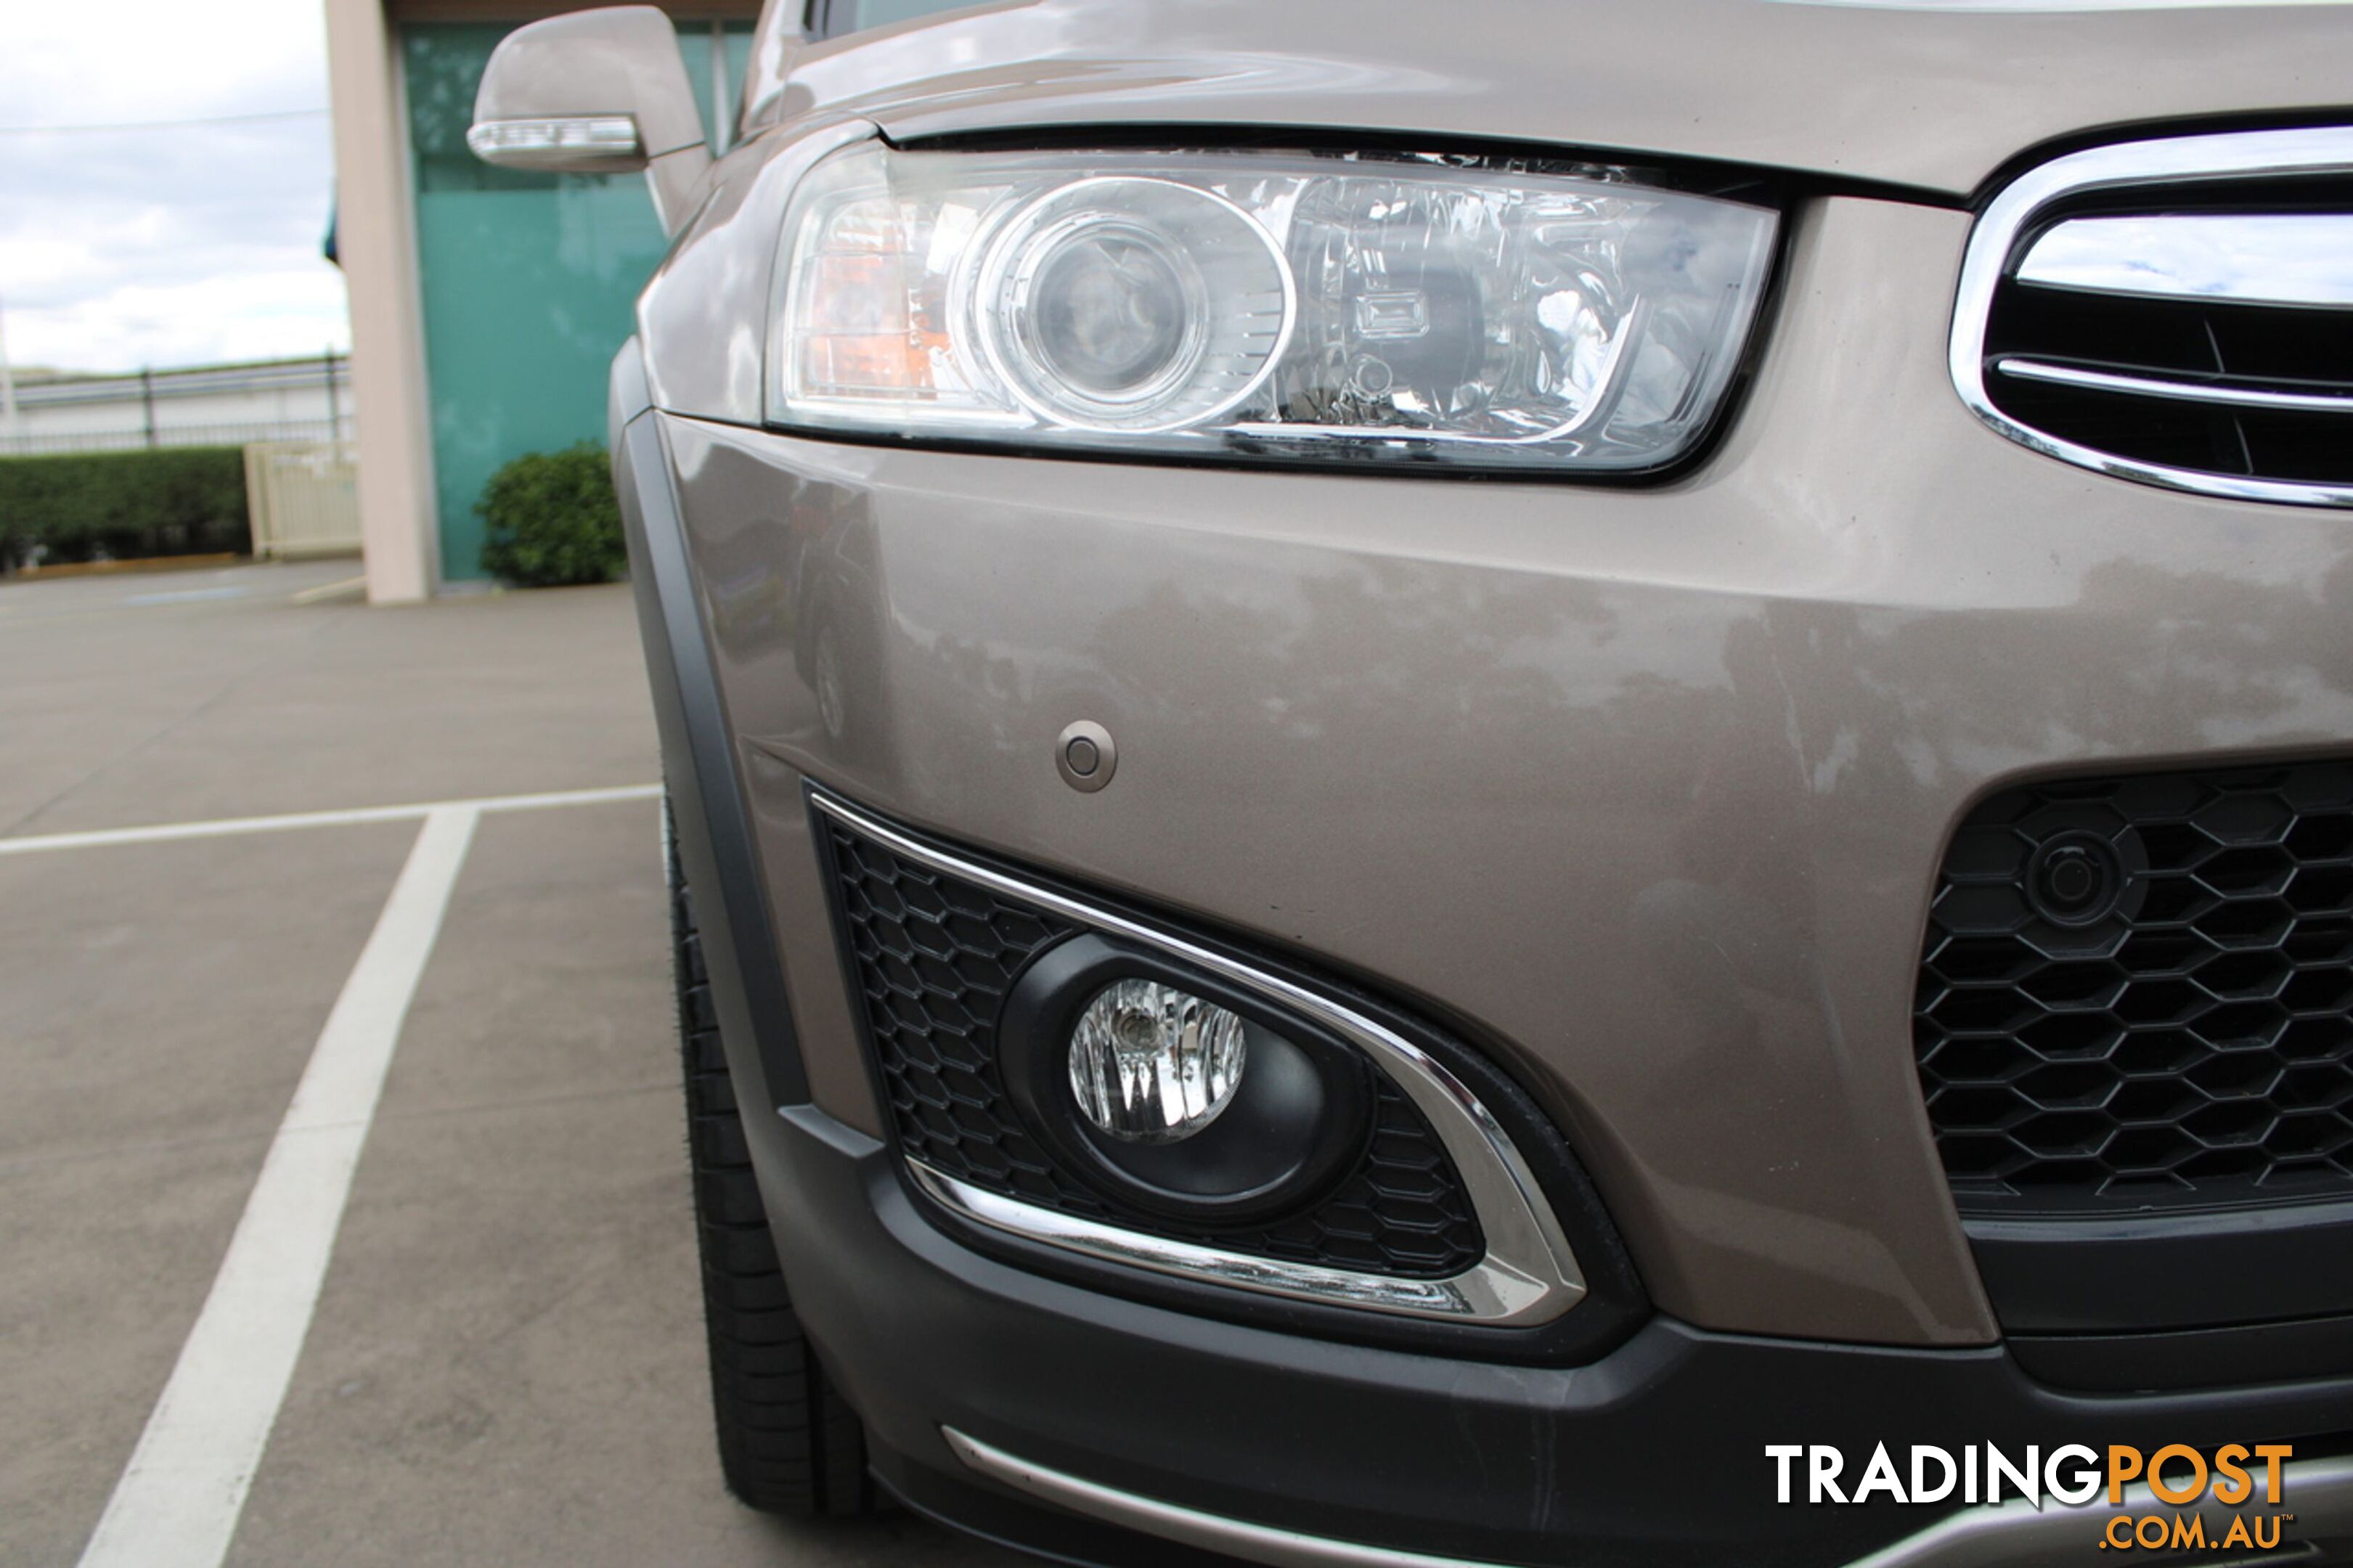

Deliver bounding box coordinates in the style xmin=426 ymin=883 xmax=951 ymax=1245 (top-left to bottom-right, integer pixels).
xmin=1951 ymin=127 xmax=2353 ymax=506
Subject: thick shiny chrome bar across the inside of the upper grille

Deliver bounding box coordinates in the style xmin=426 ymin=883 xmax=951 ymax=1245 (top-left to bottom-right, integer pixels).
xmin=2017 ymin=212 xmax=2353 ymax=309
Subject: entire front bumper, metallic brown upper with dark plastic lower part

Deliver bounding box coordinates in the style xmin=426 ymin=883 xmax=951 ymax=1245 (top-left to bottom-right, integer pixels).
xmin=621 ymin=180 xmax=2353 ymax=1564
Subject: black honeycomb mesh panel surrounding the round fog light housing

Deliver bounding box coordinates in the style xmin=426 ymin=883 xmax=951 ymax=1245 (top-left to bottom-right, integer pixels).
xmin=817 ymin=817 xmax=1487 ymax=1278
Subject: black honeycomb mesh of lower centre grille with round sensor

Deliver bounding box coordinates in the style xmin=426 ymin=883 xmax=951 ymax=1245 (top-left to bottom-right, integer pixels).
xmin=1913 ymin=763 xmax=2353 ymax=1212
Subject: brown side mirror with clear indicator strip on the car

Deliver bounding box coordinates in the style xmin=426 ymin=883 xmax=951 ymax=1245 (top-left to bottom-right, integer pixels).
xmin=466 ymin=4 xmax=711 ymax=233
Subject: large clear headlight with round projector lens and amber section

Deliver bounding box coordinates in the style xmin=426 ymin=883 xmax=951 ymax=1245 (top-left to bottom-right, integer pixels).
xmin=770 ymin=142 xmax=1774 ymax=471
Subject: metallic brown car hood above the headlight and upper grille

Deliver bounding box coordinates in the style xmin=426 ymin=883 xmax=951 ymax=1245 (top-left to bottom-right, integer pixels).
xmin=751 ymin=0 xmax=2353 ymax=197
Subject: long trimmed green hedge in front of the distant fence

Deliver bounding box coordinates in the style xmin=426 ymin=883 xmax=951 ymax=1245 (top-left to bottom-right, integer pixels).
xmin=0 ymin=447 xmax=252 ymax=568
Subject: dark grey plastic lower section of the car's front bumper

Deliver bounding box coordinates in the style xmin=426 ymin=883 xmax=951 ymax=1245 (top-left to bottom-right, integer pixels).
xmin=749 ymin=1087 xmax=2353 ymax=1568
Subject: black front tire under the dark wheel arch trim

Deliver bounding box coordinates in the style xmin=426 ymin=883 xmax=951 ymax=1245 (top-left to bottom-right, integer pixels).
xmin=664 ymin=805 xmax=876 ymax=1519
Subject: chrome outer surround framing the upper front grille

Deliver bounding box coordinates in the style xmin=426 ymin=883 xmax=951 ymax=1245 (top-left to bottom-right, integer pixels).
xmin=1949 ymin=127 xmax=2353 ymax=506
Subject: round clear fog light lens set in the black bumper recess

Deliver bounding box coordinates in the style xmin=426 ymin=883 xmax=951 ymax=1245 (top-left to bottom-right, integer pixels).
xmin=1071 ymin=979 xmax=1247 ymax=1144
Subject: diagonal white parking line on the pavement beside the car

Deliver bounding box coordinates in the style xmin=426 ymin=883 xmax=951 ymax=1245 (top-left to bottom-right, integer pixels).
xmin=82 ymin=805 xmax=480 ymax=1568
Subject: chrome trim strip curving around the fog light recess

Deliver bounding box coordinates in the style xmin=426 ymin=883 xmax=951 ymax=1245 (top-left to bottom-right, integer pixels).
xmin=810 ymin=788 xmax=1586 ymax=1328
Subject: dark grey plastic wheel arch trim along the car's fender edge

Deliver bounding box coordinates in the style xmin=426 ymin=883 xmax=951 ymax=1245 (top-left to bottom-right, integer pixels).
xmin=609 ymin=339 xmax=810 ymax=1106
